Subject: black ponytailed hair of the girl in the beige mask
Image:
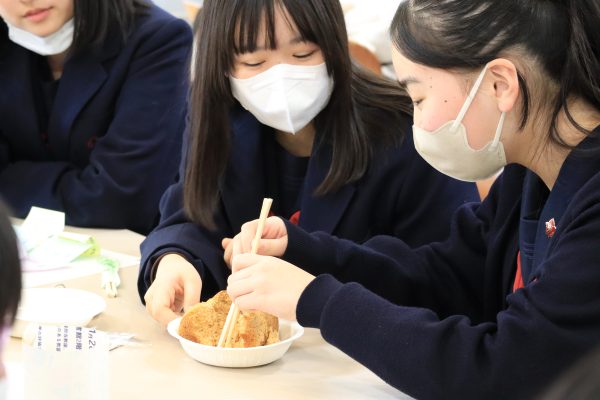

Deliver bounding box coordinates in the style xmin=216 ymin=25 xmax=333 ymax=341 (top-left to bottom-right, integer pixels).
xmin=391 ymin=0 xmax=600 ymax=147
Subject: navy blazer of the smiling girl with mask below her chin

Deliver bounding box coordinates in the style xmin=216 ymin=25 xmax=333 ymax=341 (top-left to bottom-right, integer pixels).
xmin=0 ymin=5 xmax=192 ymax=233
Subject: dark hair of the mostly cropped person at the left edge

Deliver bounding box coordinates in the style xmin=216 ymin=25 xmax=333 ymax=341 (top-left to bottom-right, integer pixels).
xmin=0 ymin=203 xmax=21 ymax=330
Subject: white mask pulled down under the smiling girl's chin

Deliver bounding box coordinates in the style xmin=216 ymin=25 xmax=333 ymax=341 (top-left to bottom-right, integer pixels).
xmin=6 ymin=18 xmax=75 ymax=56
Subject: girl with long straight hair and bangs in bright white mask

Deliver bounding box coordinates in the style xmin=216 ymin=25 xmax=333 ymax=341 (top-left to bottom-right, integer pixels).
xmin=138 ymin=0 xmax=478 ymax=323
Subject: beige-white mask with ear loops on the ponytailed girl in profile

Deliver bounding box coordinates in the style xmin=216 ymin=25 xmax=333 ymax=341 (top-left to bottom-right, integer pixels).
xmin=413 ymin=66 xmax=506 ymax=182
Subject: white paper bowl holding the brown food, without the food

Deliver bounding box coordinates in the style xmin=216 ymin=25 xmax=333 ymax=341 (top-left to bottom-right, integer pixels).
xmin=167 ymin=318 xmax=304 ymax=368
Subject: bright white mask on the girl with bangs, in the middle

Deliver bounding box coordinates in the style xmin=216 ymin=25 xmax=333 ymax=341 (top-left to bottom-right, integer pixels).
xmin=229 ymin=63 xmax=333 ymax=133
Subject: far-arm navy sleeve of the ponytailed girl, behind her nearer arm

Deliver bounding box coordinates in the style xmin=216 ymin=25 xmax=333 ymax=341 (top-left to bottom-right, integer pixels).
xmin=283 ymin=188 xmax=492 ymax=317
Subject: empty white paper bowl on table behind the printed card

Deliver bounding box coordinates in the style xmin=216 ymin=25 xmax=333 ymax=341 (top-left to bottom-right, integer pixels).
xmin=11 ymin=288 xmax=106 ymax=337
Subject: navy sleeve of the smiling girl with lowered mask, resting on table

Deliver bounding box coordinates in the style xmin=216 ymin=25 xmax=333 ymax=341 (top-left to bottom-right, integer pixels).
xmin=0 ymin=19 xmax=192 ymax=232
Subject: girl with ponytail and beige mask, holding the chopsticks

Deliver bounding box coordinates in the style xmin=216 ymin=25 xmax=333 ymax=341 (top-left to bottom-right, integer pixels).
xmin=228 ymin=0 xmax=600 ymax=399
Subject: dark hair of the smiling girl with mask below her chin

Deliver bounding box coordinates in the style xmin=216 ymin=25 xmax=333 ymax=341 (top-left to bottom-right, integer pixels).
xmin=70 ymin=0 xmax=148 ymax=54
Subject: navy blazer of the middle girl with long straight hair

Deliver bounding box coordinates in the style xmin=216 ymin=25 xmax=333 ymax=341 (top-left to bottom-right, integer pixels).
xmin=138 ymin=108 xmax=479 ymax=300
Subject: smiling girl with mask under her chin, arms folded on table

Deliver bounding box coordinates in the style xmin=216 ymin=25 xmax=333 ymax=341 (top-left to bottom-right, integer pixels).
xmin=0 ymin=0 xmax=192 ymax=233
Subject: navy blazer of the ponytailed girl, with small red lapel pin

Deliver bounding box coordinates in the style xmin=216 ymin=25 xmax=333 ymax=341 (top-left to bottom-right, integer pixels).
xmin=283 ymin=129 xmax=600 ymax=399
